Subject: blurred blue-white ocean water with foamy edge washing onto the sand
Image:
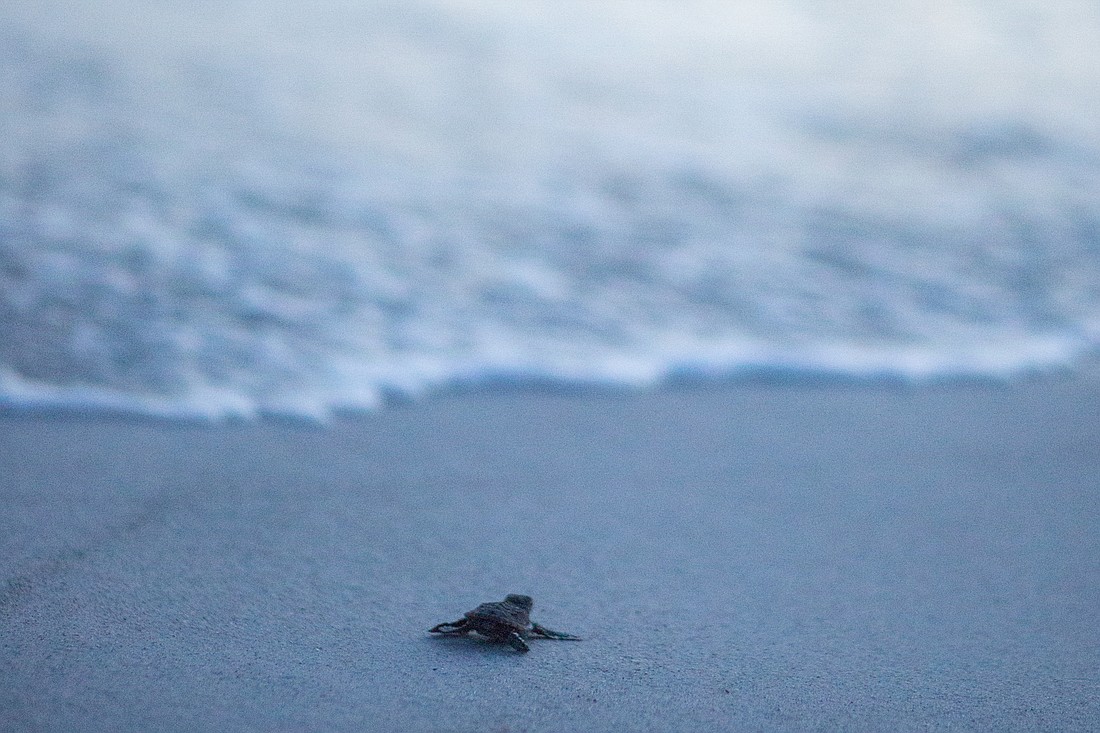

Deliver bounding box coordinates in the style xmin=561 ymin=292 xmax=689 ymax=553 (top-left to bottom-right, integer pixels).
xmin=0 ymin=0 xmax=1100 ymax=416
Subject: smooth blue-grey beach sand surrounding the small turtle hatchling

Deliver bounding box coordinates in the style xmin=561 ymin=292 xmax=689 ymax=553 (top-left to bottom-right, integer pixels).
xmin=0 ymin=379 xmax=1100 ymax=733
